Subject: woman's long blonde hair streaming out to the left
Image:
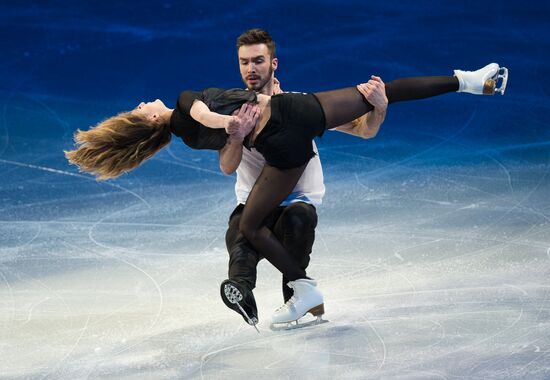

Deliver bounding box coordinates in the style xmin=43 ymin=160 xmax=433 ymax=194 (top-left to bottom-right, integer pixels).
xmin=65 ymin=112 xmax=172 ymax=180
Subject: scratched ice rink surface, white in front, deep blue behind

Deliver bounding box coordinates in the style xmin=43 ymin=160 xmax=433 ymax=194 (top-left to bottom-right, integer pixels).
xmin=0 ymin=1 xmax=550 ymax=379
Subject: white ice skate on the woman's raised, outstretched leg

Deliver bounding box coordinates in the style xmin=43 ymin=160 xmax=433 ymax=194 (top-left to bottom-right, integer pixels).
xmin=454 ymin=63 xmax=508 ymax=95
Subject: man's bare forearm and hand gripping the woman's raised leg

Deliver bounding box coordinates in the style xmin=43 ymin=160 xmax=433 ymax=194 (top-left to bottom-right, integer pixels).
xmin=334 ymin=76 xmax=388 ymax=139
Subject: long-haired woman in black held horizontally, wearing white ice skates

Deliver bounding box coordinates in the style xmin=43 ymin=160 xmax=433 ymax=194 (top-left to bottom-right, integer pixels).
xmin=65 ymin=63 xmax=508 ymax=324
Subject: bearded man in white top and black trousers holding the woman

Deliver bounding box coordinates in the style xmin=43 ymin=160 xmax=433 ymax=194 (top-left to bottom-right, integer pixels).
xmin=220 ymin=29 xmax=387 ymax=325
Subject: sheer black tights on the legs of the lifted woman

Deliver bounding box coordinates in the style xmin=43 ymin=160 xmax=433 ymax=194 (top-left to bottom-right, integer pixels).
xmin=240 ymin=76 xmax=458 ymax=281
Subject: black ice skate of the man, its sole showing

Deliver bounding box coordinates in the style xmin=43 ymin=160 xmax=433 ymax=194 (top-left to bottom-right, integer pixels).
xmin=220 ymin=280 xmax=260 ymax=333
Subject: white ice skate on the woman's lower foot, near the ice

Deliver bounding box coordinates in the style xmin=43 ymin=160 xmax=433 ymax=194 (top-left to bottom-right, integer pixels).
xmin=271 ymin=279 xmax=328 ymax=330
